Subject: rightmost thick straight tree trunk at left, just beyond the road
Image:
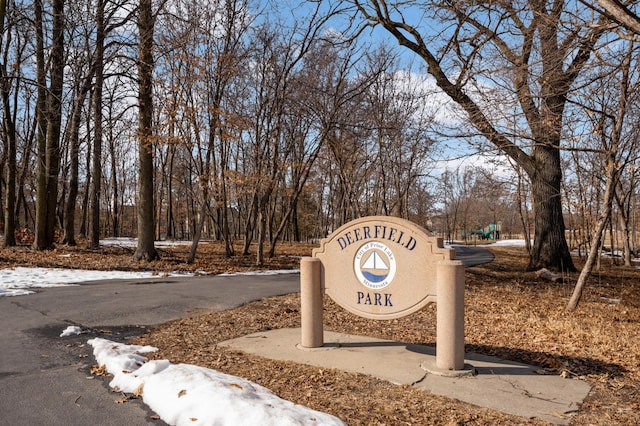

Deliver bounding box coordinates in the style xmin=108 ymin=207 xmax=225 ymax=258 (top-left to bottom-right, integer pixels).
xmin=134 ymin=0 xmax=159 ymax=261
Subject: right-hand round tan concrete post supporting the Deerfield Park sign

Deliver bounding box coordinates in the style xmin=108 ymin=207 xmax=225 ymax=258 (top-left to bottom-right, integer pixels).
xmin=436 ymin=260 xmax=464 ymax=370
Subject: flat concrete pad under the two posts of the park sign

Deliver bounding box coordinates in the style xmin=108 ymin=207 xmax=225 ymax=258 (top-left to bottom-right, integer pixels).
xmin=219 ymin=328 xmax=591 ymax=424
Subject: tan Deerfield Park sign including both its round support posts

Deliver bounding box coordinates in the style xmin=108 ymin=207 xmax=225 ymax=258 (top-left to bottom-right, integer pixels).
xmin=300 ymin=216 xmax=464 ymax=371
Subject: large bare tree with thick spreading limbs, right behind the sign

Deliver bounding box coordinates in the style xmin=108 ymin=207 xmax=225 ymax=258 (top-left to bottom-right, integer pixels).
xmin=354 ymin=0 xmax=606 ymax=270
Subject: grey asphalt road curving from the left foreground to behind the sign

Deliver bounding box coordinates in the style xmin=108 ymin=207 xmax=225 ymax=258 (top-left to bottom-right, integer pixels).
xmin=0 ymin=247 xmax=492 ymax=426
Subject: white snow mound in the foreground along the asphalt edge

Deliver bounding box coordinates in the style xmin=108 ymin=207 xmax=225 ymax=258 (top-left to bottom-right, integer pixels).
xmin=88 ymin=338 xmax=345 ymax=426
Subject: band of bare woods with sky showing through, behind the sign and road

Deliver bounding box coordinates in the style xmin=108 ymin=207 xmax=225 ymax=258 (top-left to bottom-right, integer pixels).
xmin=0 ymin=0 xmax=639 ymax=269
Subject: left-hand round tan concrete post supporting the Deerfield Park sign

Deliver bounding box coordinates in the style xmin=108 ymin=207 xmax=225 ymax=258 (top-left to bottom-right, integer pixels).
xmin=300 ymin=257 xmax=324 ymax=348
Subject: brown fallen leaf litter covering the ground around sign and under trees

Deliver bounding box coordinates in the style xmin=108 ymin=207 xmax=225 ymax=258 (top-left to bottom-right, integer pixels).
xmin=0 ymin=243 xmax=640 ymax=425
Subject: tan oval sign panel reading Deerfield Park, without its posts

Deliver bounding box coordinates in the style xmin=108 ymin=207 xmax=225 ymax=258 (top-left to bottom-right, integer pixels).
xmin=313 ymin=216 xmax=455 ymax=319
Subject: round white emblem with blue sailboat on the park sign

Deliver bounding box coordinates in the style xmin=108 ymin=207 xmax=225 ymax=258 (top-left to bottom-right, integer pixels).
xmin=353 ymin=241 xmax=396 ymax=290
